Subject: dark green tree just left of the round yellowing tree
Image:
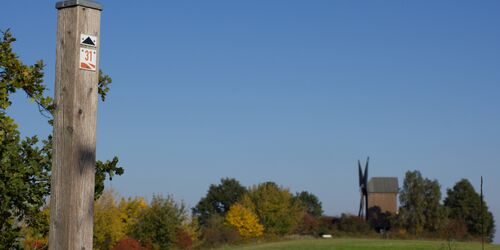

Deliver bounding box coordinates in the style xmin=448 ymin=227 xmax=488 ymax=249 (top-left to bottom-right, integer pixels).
xmin=193 ymin=178 xmax=247 ymax=226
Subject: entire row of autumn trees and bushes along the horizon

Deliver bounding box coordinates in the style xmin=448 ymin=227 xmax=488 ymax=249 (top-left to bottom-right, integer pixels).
xmin=14 ymin=174 xmax=495 ymax=250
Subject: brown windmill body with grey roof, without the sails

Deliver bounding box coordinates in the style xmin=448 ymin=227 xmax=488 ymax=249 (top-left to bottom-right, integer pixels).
xmin=368 ymin=177 xmax=399 ymax=214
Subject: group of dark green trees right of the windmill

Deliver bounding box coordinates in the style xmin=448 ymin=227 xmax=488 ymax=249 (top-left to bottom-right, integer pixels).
xmin=391 ymin=171 xmax=495 ymax=242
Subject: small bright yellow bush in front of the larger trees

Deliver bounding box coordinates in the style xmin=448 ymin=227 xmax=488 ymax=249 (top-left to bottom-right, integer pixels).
xmin=226 ymin=203 xmax=264 ymax=238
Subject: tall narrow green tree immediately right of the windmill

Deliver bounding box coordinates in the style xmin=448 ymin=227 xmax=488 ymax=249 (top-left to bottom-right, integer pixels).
xmin=399 ymin=171 xmax=425 ymax=235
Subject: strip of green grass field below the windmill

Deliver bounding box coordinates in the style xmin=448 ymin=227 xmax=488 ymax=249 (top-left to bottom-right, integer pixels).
xmin=220 ymin=239 xmax=500 ymax=250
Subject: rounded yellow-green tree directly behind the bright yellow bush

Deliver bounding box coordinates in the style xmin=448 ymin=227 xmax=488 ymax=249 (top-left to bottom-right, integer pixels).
xmin=241 ymin=182 xmax=302 ymax=235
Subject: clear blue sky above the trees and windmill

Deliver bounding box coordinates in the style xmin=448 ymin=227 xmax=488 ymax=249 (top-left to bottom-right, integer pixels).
xmin=0 ymin=0 xmax=500 ymax=242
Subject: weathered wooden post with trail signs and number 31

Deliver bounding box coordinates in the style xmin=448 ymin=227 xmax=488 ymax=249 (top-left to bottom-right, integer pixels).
xmin=49 ymin=0 xmax=102 ymax=250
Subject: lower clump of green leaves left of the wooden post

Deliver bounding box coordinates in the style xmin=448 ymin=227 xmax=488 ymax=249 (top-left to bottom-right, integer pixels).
xmin=0 ymin=119 xmax=50 ymax=248
